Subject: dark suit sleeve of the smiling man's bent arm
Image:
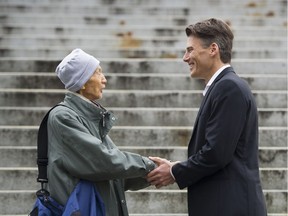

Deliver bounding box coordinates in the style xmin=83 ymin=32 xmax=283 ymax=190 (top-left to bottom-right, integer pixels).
xmin=172 ymin=80 xmax=247 ymax=189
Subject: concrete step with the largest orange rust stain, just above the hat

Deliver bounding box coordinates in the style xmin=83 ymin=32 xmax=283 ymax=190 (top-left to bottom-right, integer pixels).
xmin=0 ymin=35 xmax=287 ymax=48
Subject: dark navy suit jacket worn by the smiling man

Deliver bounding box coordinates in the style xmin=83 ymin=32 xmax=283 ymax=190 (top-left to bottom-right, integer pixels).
xmin=172 ymin=67 xmax=267 ymax=216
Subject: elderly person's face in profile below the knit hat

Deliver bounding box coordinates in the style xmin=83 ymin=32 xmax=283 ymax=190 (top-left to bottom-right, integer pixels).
xmin=80 ymin=66 xmax=107 ymax=100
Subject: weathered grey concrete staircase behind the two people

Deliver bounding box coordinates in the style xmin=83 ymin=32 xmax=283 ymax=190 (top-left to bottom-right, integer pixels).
xmin=0 ymin=0 xmax=288 ymax=216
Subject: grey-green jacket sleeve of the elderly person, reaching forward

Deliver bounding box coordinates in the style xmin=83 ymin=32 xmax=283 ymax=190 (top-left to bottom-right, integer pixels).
xmin=49 ymin=110 xmax=155 ymax=181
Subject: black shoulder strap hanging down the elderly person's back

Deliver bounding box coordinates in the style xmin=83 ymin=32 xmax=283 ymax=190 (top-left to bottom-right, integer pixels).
xmin=37 ymin=104 xmax=60 ymax=184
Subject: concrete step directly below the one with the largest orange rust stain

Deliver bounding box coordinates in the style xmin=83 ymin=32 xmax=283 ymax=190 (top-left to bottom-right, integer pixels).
xmin=0 ymin=46 xmax=287 ymax=59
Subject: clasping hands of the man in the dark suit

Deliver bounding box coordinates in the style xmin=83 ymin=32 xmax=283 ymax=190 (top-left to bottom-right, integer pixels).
xmin=147 ymin=157 xmax=180 ymax=188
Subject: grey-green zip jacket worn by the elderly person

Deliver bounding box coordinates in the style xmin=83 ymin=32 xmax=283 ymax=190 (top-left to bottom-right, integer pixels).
xmin=48 ymin=92 xmax=155 ymax=216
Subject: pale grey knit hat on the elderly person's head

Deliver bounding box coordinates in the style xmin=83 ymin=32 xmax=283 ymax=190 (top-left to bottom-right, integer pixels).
xmin=55 ymin=49 xmax=100 ymax=92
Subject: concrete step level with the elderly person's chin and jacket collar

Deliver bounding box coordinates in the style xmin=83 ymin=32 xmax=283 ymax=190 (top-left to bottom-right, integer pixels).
xmin=0 ymin=89 xmax=287 ymax=108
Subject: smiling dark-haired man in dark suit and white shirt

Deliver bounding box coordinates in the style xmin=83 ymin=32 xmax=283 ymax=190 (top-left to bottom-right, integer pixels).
xmin=147 ymin=18 xmax=267 ymax=216
